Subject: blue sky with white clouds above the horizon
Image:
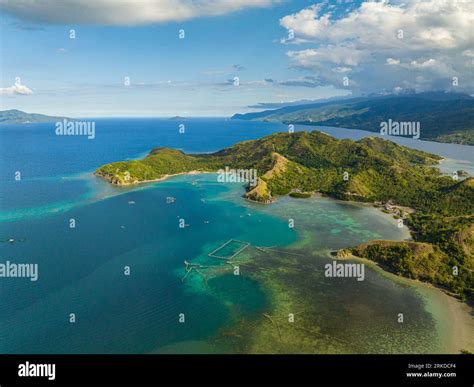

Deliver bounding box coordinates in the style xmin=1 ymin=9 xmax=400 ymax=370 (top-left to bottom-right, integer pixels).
xmin=0 ymin=0 xmax=474 ymax=117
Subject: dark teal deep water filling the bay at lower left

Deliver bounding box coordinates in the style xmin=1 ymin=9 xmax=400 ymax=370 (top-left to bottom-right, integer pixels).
xmin=0 ymin=177 xmax=295 ymax=353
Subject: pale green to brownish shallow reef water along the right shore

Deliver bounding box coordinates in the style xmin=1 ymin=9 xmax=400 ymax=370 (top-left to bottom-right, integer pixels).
xmin=233 ymin=197 xmax=440 ymax=353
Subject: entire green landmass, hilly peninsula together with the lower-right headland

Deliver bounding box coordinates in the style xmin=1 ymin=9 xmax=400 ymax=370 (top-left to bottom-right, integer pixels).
xmin=95 ymin=131 xmax=474 ymax=298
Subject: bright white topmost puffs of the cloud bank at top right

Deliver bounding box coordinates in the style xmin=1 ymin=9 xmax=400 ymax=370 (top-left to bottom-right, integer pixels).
xmin=280 ymin=0 xmax=474 ymax=49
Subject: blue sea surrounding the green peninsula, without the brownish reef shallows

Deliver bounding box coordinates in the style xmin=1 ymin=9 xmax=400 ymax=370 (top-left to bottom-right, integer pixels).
xmin=0 ymin=118 xmax=474 ymax=353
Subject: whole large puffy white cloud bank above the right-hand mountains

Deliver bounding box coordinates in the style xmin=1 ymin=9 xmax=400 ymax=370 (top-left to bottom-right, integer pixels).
xmin=280 ymin=0 xmax=474 ymax=92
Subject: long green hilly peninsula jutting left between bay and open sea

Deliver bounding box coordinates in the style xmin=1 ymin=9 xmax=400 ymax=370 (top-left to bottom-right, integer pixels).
xmin=96 ymin=131 xmax=462 ymax=209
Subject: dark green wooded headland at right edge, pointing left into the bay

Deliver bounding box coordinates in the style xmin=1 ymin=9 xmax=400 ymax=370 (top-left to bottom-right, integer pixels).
xmin=352 ymin=178 xmax=474 ymax=298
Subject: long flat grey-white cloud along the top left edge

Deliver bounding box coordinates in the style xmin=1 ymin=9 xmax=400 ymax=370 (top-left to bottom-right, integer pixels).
xmin=0 ymin=0 xmax=279 ymax=25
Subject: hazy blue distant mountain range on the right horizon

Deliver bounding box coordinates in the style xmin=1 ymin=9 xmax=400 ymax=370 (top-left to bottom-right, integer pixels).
xmin=232 ymin=92 xmax=474 ymax=145
